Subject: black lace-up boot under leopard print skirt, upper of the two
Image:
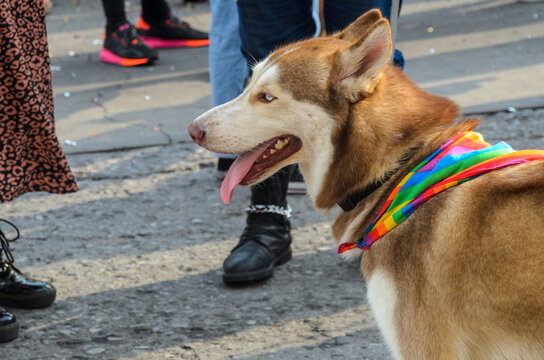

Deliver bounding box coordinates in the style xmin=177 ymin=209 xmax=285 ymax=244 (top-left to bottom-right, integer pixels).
xmin=0 ymin=219 xmax=57 ymax=309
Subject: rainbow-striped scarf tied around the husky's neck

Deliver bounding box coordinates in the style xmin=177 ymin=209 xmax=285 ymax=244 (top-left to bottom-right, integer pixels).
xmin=338 ymin=131 xmax=544 ymax=253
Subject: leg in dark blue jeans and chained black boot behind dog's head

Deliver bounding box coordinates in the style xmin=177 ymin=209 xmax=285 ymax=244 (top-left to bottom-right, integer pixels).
xmin=223 ymin=0 xmax=315 ymax=283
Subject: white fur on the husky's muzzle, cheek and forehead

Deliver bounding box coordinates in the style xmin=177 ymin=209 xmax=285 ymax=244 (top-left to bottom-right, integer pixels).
xmin=191 ymin=60 xmax=334 ymax=205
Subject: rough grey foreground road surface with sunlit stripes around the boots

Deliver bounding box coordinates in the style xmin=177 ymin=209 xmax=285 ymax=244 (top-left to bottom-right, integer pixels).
xmin=0 ymin=109 xmax=544 ymax=360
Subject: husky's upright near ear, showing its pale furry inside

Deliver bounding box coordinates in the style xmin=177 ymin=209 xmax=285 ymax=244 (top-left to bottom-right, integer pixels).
xmin=331 ymin=18 xmax=393 ymax=102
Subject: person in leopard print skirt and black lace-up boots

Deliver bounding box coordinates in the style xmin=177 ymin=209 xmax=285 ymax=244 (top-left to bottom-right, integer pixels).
xmin=0 ymin=0 xmax=78 ymax=344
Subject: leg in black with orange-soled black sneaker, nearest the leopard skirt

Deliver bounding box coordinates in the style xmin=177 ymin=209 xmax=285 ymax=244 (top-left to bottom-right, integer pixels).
xmin=100 ymin=0 xmax=159 ymax=66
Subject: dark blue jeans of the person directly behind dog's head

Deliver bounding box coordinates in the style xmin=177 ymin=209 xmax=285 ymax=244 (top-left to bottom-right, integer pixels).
xmin=236 ymin=0 xmax=402 ymax=64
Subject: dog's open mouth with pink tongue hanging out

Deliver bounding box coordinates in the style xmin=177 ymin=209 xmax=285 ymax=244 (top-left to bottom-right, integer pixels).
xmin=221 ymin=135 xmax=302 ymax=204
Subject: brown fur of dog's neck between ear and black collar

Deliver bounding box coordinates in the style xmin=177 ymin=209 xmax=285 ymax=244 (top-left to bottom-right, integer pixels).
xmin=314 ymin=67 xmax=459 ymax=210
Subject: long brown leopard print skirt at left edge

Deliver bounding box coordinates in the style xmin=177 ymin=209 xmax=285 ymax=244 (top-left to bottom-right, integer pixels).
xmin=0 ymin=0 xmax=77 ymax=203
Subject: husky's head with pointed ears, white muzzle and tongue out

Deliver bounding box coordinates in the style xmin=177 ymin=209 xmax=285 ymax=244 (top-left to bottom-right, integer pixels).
xmin=189 ymin=10 xmax=454 ymax=207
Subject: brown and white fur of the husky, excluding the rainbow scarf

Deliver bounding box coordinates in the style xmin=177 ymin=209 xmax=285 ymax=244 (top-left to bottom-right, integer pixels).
xmin=190 ymin=11 xmax=544 ymax=360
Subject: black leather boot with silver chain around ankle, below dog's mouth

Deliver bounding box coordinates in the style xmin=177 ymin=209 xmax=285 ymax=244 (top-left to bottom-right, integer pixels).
xmin=223 ymin=166 xmax=292 ymax=284
